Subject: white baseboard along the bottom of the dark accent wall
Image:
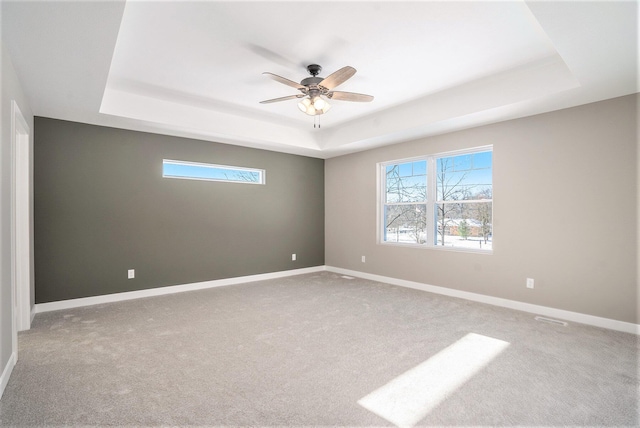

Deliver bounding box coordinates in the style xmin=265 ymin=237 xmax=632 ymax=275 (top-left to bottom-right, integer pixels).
xmin=35 ymin=266 xmax=325 ymax=313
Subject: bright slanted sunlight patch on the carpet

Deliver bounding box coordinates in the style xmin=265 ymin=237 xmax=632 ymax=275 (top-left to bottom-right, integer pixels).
xmin=358 ymin=333 xmax=509 ymax=428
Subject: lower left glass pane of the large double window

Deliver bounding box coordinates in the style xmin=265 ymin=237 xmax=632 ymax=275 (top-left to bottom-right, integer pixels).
xmin=383 ymin=204 xmax=427 ymax=244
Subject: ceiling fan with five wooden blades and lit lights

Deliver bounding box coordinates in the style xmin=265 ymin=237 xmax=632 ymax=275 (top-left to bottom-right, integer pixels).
xmin=260 ymin=64 xmax=373 ymax=116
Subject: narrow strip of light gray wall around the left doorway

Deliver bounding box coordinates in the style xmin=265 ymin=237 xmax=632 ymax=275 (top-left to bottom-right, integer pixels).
xmin=0 ymin=40 xmax=33 ymax=386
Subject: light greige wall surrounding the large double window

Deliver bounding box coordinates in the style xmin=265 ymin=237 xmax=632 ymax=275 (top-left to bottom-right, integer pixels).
xmin=325 ymin=95 xmax=639 ymax=323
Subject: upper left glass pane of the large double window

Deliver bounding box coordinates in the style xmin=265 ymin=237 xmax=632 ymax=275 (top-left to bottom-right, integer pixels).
xmin=385 ymin=161 xmax=427 ymax=203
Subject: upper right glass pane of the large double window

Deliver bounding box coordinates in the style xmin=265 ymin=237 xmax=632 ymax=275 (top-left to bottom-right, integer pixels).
xmin=436 ymin=152 xmax=493 ymax=201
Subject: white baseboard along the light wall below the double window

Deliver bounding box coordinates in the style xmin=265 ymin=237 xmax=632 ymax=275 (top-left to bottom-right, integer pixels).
xmin=326 ymin=266 xmax=640 ymax=335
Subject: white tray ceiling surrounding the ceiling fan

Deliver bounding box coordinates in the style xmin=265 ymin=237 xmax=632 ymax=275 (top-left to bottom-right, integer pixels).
xmin=2 ymin=0 xmax=639 ymax=158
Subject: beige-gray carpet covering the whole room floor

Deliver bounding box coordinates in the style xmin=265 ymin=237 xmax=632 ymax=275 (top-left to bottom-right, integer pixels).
xmin=0 ymin=272 xmax=639 ymax=427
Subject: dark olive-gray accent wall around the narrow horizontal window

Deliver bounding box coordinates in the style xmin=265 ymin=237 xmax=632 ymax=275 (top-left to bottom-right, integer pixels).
xmin=34 ymin=117 xmax=324 ymax=303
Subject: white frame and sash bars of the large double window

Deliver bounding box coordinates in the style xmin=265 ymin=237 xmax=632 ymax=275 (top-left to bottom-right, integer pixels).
xmin=376 ymin=144 xmax=494 ymax=254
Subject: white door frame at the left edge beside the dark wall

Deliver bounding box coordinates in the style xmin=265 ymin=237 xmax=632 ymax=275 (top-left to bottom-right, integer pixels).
xmin=11 ymin=100 xmax=33 ymax=342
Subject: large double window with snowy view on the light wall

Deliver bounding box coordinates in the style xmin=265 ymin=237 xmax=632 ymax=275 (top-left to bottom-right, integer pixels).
xmin=379 ymin=147 xmax=493 ymax=251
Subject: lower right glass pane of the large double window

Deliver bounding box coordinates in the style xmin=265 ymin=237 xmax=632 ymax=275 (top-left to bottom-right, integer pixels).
xmin=435 ymin=202 xmax=493 ymax=250
